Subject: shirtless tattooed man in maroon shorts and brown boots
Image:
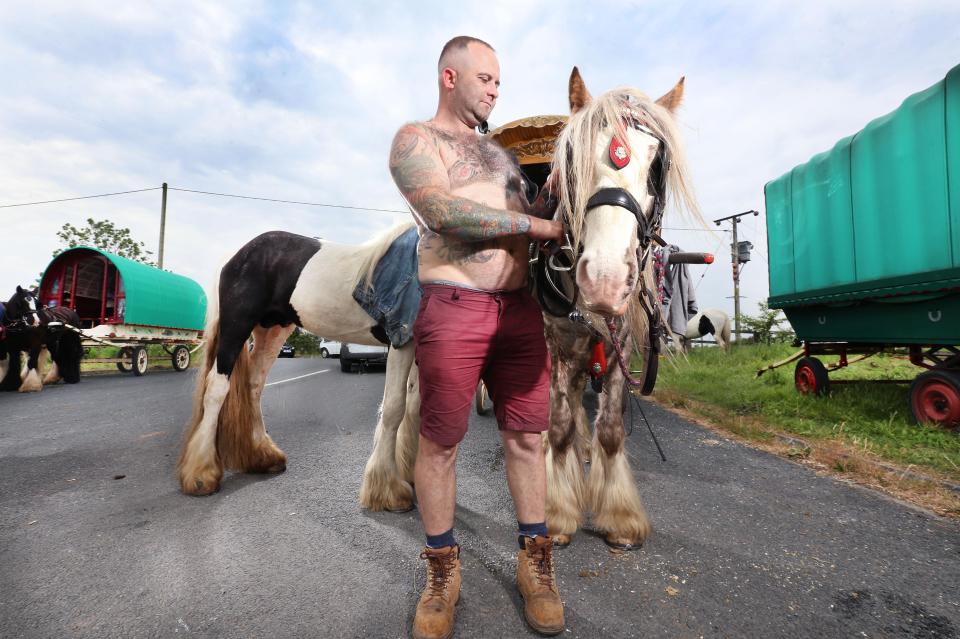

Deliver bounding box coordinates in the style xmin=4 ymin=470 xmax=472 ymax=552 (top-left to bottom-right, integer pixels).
xmin=390 ymin=36 xmax=564 ymax=639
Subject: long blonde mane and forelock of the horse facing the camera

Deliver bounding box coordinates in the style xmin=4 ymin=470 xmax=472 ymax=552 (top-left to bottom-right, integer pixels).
xmin=552 ymin=87 xmax=702 ymax=251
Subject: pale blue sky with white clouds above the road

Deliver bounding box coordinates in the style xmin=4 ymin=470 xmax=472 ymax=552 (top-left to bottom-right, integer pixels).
xmin=0 ymin=0 xmax=960 ymax=322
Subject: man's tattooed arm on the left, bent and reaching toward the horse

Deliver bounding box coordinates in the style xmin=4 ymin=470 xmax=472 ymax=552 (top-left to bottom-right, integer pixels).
xmin=390 ymin=124 xmax=530 ymax=242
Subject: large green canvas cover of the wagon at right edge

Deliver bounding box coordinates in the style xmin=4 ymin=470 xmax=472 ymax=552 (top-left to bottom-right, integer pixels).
xmin=764 ymin=66 xmax=960 ymax=308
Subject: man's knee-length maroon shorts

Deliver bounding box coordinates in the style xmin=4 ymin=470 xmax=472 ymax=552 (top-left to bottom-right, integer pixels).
xmin=413 ymin=284 xmax=550 ymax=446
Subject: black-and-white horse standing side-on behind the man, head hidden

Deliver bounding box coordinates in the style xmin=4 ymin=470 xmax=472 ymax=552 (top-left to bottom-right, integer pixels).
xmin=177 ymin=224 xmax=419 ymax=511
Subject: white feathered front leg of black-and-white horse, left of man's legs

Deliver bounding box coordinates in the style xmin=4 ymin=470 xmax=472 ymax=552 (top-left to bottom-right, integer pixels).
xmin=360 ymin=343 xmax=414 ymax=512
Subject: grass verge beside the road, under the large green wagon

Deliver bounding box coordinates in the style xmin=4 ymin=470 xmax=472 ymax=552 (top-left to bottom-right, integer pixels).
xmin=654 ymin=345 xmax=960 ymax=517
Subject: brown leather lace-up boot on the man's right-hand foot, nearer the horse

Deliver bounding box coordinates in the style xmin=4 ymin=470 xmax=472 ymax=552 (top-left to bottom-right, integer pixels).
xmin=517 ymin=535 xmax=564 ymax=635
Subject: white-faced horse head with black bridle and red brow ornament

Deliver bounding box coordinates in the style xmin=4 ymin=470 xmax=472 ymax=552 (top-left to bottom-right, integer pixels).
xmin=553 ymin=67 xmax=699 ymax=317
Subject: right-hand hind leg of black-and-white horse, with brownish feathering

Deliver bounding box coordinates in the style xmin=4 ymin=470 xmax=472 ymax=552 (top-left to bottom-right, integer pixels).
xmin=238 ymin=325 xmax=296 ymax=473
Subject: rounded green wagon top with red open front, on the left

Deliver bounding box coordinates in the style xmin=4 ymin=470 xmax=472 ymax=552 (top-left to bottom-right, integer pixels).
xmin=40 ymin=246 xmax=207 ymax=331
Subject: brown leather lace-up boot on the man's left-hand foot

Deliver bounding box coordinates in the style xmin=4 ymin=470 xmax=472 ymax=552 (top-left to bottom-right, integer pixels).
xmin=413 ymin=546 xmax=460 ymax=639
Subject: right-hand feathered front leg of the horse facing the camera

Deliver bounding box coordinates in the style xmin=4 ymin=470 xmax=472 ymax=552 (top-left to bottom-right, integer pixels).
xmin=587 ymin=368 xmax=651 ymax=549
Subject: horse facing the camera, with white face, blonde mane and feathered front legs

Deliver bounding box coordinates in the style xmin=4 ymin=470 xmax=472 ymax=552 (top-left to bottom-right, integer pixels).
xmin=546 ymin=68 xmax=699 ymax=548
